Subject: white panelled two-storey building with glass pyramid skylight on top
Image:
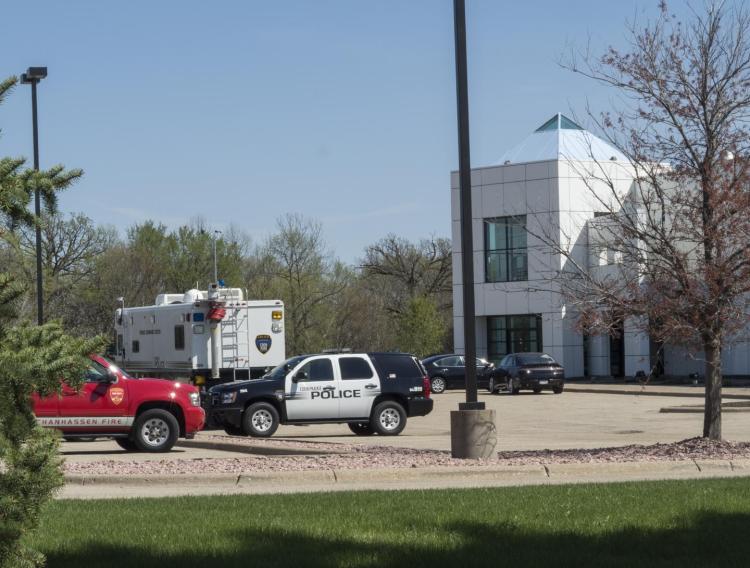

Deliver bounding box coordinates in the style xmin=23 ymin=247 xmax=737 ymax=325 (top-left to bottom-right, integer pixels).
xmin=451 ymin=114 xmax=750 ymax=377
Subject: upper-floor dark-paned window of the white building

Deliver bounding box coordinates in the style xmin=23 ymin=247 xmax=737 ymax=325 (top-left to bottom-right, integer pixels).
xmin=484 ymin=215 xmax=529 ymax=282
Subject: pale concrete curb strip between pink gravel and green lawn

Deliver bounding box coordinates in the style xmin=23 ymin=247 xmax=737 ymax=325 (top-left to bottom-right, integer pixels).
xmin=58 ymin=459 xmax=750 ymax=499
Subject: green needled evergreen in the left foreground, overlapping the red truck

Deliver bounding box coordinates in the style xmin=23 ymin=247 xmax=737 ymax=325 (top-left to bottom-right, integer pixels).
xmin=0 ymin=74 xmax=100 ymax=567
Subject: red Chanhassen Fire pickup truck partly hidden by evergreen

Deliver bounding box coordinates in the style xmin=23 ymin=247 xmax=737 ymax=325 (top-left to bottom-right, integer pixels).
xmin=33 ymin=355 xmax=206 ymax=452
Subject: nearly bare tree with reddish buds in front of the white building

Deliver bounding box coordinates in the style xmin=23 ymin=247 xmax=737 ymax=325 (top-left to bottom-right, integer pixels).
xmin=558 ymin=2 xmax=750 ymax=440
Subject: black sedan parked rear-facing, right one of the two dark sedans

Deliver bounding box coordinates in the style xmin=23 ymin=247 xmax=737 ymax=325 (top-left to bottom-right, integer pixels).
xmin=487 ymin=353 xmax=565 ymax=394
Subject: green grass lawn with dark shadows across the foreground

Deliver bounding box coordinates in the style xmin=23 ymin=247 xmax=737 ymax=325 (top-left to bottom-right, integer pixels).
xmin=31 ymin=478 xmax=750 ymax=568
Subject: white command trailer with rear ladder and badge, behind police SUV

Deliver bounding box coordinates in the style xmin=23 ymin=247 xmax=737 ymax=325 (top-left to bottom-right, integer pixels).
xmin=115 ymin=284 xmax=286 ymax=385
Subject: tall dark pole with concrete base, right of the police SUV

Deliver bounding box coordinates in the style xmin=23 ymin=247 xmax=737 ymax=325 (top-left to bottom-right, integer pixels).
xmin=451 ymin=0 xmax=497 ymax=458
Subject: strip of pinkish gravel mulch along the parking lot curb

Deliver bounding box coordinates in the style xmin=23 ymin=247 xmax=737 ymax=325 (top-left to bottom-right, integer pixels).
xmin=65 ymin=436 xmax=750 ymax=475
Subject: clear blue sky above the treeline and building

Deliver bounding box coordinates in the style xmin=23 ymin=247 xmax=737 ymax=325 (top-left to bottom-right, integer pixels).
xmin=0 ymin=0 xmax=682 ymax=262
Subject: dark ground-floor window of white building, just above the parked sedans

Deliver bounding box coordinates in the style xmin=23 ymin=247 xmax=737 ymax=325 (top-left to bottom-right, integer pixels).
xmin=487 ymin=314 xmax=544 ymax=364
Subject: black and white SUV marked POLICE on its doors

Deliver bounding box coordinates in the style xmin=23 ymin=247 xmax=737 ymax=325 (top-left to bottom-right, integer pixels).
xmin=209 ymin=353 xmax=433 ymax=437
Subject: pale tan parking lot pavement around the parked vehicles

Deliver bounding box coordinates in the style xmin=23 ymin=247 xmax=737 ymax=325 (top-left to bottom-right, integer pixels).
xmin=62 ymin=389 xmax=750 ymax=461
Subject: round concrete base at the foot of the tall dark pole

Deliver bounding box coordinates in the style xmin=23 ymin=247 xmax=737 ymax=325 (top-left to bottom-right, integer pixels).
xmin=451 ymin=410 xmax=497 ymax=459
